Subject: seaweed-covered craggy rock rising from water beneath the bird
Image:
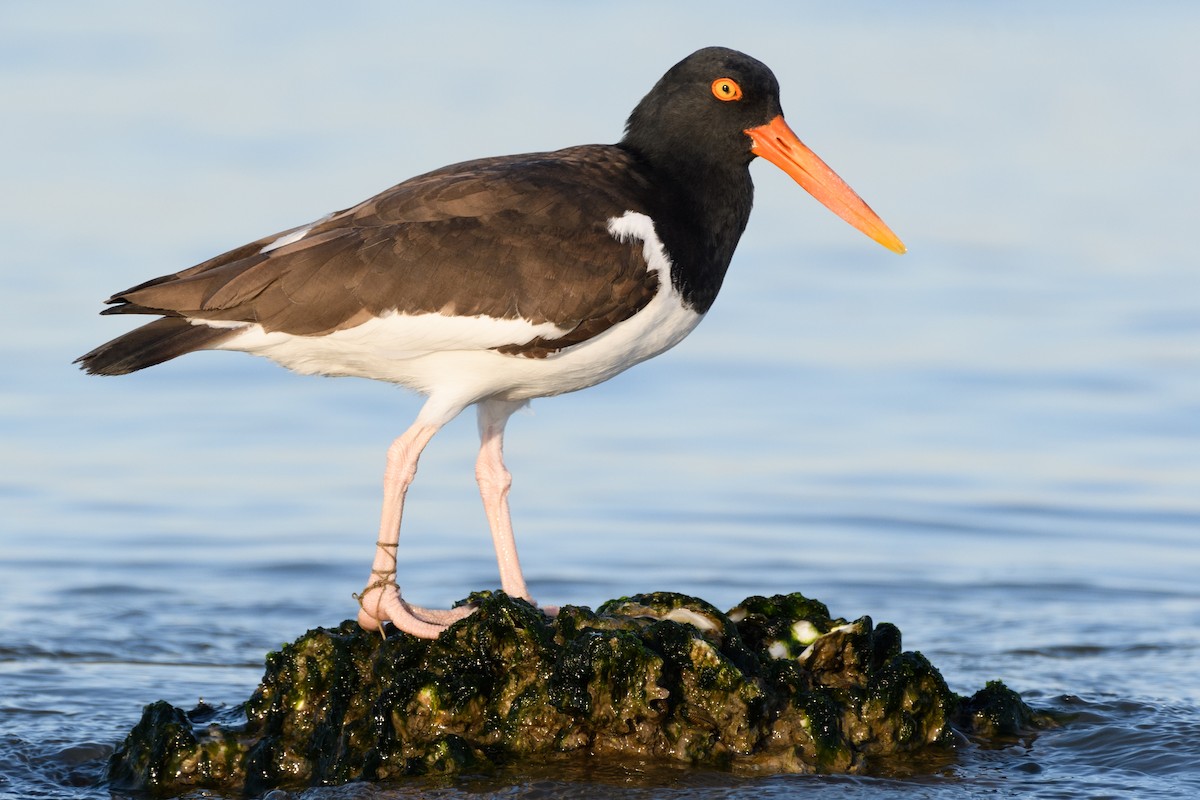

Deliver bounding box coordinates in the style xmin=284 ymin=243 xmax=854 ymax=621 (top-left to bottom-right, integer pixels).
xmin=109 ymin=593 xmax=1042 ymax=793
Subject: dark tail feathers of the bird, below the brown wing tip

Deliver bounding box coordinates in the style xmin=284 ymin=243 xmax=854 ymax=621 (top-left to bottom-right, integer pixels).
xmin=74 ymin=317 xmax=238 ymax=375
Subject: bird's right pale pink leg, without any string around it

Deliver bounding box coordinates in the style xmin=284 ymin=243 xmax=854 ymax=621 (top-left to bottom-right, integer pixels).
xmin=475 ymin=399 xmax=552 ymax=604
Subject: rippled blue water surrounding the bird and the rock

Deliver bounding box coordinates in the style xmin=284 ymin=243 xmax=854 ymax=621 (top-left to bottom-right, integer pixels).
xmin=0 ymin=2 xmax=1200 ymax=800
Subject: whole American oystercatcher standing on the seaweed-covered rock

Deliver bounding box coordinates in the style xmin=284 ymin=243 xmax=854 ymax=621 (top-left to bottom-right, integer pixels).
xmin=77 ymin=47 xmax=905 ymax=637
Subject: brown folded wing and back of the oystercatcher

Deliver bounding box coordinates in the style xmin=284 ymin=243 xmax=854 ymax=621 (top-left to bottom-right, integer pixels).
xmin=106 ymin=145 xmax=659 ymax=345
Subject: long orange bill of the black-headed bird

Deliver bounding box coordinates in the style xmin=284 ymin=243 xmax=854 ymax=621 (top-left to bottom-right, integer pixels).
xmin=746 ymin=115 xmax=907 ymax=253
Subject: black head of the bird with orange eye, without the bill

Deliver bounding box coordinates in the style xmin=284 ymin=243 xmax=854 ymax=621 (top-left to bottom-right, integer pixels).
xmin=622 ymin=47 xmax=782 ymax=172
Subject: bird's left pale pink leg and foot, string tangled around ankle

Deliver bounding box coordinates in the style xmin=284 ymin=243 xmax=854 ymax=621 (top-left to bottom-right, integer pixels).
xmin=358 ymin=421 xmax=473 ymax=639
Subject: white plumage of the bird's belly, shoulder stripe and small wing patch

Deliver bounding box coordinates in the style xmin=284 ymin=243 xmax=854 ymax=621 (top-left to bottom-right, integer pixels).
xmin=191 ymin=211 xmax=701 ymax=423
